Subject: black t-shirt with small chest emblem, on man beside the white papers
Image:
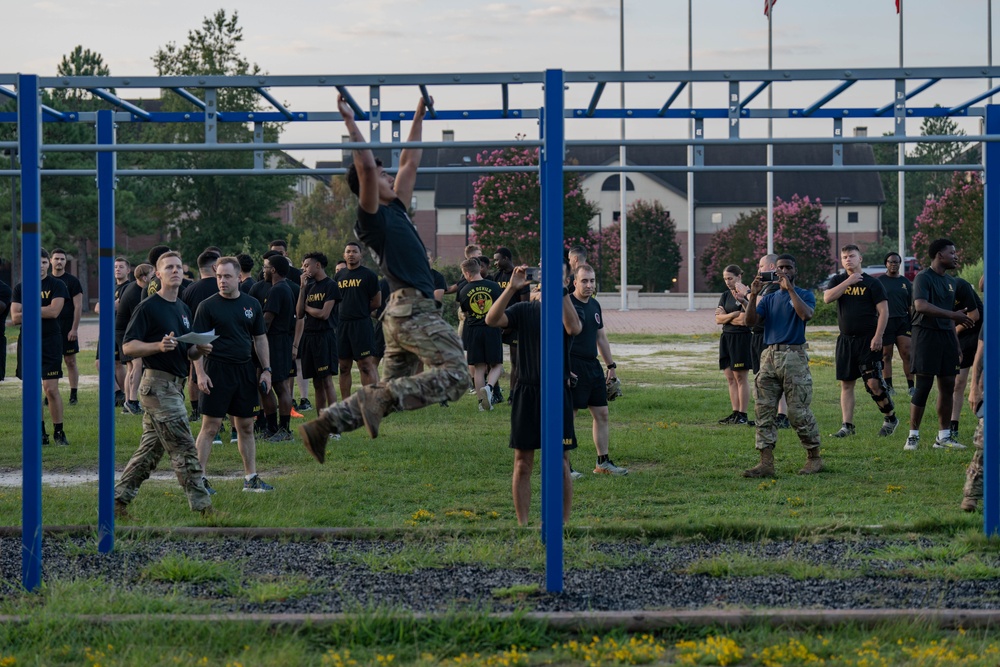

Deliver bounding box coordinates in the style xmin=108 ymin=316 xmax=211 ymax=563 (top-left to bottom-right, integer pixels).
xmin=194 ymin=292 xmax=265 ymax=364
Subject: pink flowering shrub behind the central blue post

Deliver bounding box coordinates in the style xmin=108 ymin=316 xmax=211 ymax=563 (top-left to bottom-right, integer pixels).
xmin=470 ymin=142 xmax=597 ymax=265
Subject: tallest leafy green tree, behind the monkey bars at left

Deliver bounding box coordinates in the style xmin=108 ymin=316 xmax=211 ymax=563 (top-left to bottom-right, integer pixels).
xmin=143 ymin=10 xmax=295 ymax=257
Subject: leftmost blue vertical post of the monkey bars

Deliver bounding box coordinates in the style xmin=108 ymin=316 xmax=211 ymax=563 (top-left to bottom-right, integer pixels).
xmin=17 ymin=74 xmax=42 ymax=591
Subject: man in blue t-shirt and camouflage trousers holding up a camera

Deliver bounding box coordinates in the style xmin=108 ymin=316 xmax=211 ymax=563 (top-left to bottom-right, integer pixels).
xmin=743 ymin=254 xmax=823 ymax=478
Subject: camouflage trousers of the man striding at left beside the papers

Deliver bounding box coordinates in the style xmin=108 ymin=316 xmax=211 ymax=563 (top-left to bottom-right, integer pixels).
xmin=115 ymin=369 xmax=212 ymax=512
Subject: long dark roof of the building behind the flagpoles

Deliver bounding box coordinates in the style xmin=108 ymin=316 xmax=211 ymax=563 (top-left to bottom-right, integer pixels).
xmin=423 ymin=144 xmax=885 ymax=208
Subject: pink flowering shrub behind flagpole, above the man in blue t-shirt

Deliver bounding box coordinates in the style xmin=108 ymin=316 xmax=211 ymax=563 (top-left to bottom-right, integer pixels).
xmin=701 ymin=195 xmax=835 ymax=291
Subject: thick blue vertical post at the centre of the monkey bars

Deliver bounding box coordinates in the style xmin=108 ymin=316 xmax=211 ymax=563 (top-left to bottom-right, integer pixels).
xmin=539 ymin=69 xmax=566 ymax=593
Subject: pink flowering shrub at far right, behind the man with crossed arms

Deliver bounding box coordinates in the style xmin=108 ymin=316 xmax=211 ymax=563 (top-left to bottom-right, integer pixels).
xmin=913 ymin=172 xmax=983 ymax=266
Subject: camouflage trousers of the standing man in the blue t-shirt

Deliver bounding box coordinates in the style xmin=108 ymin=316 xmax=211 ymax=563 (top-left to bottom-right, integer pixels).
xmin=753 ymin=346 xmax=819 ymax=449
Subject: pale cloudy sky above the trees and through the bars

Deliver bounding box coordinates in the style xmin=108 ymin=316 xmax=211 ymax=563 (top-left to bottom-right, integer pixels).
xmin=0 ymin=0 xmax=1000 ymax=163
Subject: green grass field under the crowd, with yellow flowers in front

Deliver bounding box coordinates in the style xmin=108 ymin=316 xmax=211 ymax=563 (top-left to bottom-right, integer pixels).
xmin=0 ymin=333 xmax=1000 ymax=666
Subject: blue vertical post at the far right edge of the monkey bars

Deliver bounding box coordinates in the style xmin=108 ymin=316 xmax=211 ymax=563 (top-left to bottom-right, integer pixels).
xmin=983 ymin=104 xmax=1000 ymax=535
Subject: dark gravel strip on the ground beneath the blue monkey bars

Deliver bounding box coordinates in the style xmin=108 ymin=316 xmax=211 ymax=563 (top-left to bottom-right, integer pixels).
xmin=0 ymin=537 xmax=1000 ymax=613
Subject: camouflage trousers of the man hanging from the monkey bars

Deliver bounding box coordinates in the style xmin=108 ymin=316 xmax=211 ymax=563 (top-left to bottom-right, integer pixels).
xmin=322 ymin=293 xmax=472 ymax=433
